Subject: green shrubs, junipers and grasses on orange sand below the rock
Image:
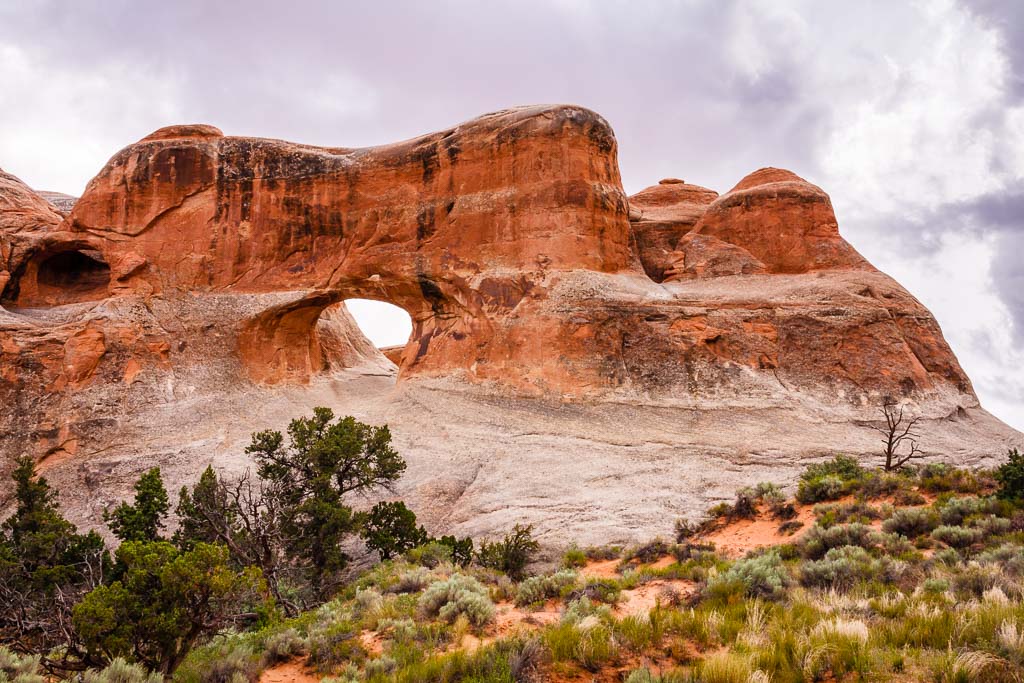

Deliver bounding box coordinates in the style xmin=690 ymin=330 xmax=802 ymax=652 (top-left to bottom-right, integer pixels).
xmin=0 ymin=410 xmax=1024 ymax=683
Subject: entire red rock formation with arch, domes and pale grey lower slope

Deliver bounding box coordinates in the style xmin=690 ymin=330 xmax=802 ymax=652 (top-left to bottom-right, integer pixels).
xmin=0 ymin=106 xmax=1020 ymax=542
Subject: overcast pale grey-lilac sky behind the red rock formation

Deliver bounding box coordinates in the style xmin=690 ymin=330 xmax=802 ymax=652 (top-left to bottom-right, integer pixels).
xmin=0 ymin=0 xmax=1024 ymax=428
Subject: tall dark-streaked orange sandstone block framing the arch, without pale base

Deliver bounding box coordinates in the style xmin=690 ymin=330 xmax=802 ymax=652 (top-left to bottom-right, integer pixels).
xmin=59 ymin=106 xmax=635 ymax=382
